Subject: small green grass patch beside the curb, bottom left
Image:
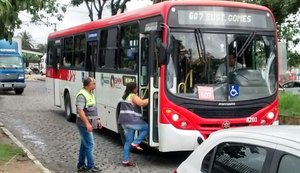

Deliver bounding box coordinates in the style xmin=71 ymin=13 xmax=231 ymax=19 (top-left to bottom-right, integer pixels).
xmin=0 ymin=144 xmax=25 ymax=162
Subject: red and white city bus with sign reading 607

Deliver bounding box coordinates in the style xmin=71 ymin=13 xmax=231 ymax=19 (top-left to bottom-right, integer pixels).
xmin=46 ymin=0 xmax=278 ymax=152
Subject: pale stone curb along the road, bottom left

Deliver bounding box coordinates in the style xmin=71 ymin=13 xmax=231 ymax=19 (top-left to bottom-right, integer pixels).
xmin=0 ymin=122 xmax=51 ymax=173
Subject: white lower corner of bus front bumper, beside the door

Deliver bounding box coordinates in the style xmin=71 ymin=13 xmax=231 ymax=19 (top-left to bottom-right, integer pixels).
xmin=159 ymin=124 xmax=204 ymax=152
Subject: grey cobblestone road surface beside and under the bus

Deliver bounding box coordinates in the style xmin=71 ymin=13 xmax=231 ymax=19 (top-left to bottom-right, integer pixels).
xmin=0 ymin=80 xmax=189 ymax=173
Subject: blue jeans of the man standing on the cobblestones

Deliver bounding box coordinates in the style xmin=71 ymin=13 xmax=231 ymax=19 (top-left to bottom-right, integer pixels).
xmin=77 ymin=126 xmax=95 ymax=169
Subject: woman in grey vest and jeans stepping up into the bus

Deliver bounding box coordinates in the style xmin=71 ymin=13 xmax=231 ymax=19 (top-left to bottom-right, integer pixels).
xmin=118 ymin=82 xmax=149 ymax=166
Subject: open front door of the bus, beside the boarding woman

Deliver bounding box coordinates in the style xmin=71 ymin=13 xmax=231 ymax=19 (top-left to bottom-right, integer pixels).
xmin=139 ymin=33 xmax=159 ymax=147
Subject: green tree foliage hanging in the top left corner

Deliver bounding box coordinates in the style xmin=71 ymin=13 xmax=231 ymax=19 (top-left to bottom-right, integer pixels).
xmin=0 ymin=0 xmax=66 ymax=40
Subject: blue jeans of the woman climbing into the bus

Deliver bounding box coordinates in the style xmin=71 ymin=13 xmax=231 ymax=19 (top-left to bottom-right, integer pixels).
xmin=122 ymin=123 xmax=148 ymax=161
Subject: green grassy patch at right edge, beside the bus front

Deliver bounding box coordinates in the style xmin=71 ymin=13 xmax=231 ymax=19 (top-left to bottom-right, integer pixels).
xmin=279 ymin=92 xmax=300 ymax=116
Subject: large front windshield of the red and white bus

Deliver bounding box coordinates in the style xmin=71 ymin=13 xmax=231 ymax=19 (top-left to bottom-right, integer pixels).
xmin=166 ymin=29 xmax=277 ymax=101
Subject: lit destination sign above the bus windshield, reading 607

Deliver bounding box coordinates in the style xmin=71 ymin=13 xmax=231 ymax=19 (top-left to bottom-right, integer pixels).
xmin=169 ymin=6 xmax=274 ymax=30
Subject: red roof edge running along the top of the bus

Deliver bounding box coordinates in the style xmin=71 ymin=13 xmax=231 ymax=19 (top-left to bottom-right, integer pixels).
xmin=48 ymin=0 xmax=272 ymax=39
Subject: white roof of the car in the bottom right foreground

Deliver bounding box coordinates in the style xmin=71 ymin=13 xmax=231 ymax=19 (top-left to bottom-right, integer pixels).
xmin=212 ymin=125 xmax=300 ymax=143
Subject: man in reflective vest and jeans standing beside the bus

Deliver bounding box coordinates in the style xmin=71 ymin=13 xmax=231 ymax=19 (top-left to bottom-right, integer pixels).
xmin=76 ymin=77 xmax=102 ymax=172
